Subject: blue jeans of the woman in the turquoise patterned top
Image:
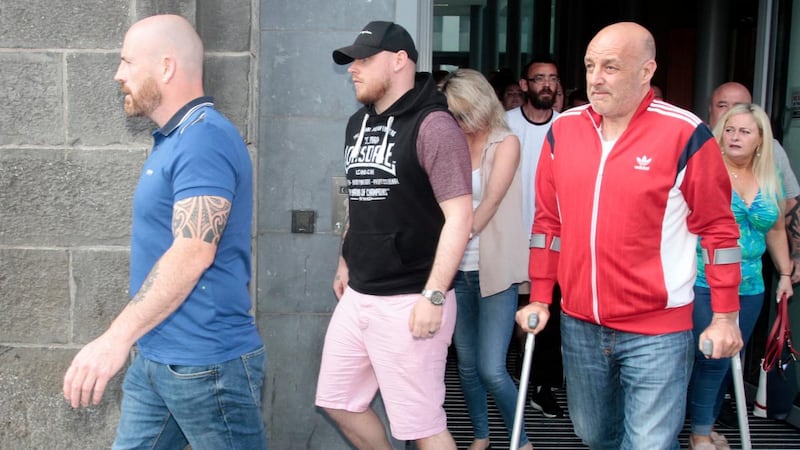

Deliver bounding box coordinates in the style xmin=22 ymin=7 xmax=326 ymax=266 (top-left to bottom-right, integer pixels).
xmin=689 ymin=286 xmax=764 ymax=436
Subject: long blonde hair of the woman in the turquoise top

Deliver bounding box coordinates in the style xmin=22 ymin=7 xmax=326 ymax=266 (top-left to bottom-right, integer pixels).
xmin=714 ymin=103 xmax=782 ymax=203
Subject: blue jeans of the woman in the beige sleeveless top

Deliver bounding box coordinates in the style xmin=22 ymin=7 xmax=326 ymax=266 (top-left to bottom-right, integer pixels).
xmin=453 ymin=271 xmax=528 ymax=446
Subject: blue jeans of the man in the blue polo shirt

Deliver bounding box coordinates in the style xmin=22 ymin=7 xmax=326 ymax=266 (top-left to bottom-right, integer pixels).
xmin=112 ymin=347 xmax=267 ymax=450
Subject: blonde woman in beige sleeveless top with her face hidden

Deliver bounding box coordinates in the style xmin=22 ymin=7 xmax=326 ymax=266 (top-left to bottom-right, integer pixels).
xmin=442 ymin=69 xmax=532 ymax=450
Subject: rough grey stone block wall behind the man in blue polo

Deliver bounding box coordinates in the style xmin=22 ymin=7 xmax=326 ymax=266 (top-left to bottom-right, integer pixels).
xmin=0 ymin=0 xmax=256 ymax=449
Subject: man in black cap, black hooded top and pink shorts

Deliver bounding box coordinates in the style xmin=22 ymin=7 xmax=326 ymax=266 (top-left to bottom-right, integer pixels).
xmin=315 ymin=17 xmax=472 ymax=450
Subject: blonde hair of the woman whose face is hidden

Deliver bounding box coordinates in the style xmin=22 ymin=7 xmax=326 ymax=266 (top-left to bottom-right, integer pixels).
xmin=441 ymin=69 xmax=508 ymax=133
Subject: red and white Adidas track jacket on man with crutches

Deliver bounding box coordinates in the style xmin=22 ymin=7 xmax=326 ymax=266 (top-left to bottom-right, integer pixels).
xmin=528 ymin=91 xmax=741 ymax=335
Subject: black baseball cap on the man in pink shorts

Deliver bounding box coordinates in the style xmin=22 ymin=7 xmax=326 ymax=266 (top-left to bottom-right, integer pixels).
xmin=333 ymin=21 xmax=417 ymax=65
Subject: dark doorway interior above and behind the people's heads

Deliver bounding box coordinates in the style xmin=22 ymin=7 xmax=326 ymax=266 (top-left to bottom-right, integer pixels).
xmin=433 ymin=0 xmax=759 ymax=112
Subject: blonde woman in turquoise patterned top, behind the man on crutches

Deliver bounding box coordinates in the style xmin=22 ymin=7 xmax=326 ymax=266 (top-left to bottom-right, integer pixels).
xmin=689 ymin=103 xmax=792 ymax=450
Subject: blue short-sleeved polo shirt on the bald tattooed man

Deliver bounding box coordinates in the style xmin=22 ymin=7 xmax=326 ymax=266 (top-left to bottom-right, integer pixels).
xmin=130 ymin=97 xmax=261 ymax=365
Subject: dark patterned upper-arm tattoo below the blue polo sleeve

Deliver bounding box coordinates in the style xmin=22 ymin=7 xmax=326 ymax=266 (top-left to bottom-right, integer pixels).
xmin=172 ymin=196 xmax=231 ymax=245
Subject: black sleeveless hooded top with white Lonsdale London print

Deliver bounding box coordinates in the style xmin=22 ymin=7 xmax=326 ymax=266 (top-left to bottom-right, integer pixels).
xmin=342 ymin=73 xmax=447 ymax=295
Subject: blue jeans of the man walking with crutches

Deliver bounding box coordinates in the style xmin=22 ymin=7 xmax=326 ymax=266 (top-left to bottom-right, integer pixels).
xmin=561 ymin=313 xmax=694 ymax=450
